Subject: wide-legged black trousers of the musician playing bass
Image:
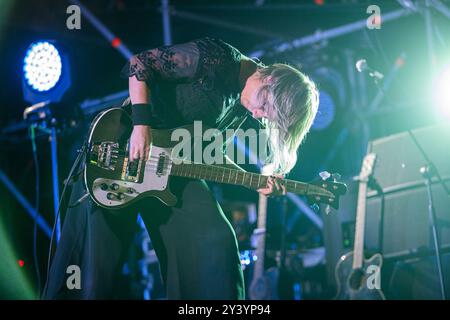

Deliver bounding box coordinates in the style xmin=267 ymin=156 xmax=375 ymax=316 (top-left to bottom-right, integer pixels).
xmin=42 ymin=177 xmax=244 ymax=300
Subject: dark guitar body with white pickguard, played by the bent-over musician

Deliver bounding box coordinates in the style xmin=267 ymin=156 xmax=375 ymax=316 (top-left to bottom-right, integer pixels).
xmin=84 ymin=108 xmax=177 ymax=209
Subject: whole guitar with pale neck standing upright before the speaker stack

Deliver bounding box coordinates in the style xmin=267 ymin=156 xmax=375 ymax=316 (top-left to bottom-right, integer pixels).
xmin=335 ymin=153 xmax=385 ymax=300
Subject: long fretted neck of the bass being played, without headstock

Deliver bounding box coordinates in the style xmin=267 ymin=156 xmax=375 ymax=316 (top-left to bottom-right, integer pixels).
xmin=171 ymin=163 xmax=327 ymax=196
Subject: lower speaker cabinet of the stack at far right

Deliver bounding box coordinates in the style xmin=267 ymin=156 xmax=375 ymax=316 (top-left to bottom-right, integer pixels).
xmin=365 ymin=182 xmax=450 ymax=255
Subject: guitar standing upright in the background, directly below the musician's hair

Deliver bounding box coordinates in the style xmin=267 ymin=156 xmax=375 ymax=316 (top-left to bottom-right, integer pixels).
xmin=248 ymin=165 xmax=279 ymax=300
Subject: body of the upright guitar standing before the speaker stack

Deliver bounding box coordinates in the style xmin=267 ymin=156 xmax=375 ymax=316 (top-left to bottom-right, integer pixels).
xmin=335 ymin=251 xmax=385 ymax=300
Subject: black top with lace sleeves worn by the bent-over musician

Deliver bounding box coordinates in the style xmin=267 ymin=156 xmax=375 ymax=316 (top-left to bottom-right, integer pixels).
xmin=122 ymin=38 xmax=248 ymax=129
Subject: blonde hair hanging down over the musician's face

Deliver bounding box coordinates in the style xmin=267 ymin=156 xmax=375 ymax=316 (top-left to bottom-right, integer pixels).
xmin=258 ymin=63 xmax=319 ymax=174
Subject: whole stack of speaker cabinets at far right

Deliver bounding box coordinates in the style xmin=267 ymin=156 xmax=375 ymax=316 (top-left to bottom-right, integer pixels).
xmin=365 ymin=125 xmax=450 ymax=254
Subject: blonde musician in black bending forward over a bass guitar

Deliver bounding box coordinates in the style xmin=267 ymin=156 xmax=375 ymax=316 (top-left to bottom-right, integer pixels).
xmin=43 ymin=38 xmax=318 ymax=299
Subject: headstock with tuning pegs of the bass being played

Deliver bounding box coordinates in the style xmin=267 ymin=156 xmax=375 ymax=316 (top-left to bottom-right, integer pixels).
xmin=306 ymin=173 xmax=347 ymax=210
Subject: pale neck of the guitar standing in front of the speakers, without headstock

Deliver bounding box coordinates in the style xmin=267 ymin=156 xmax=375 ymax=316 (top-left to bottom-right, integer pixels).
xmin=353 ymin=181 xmax=367 ymax=269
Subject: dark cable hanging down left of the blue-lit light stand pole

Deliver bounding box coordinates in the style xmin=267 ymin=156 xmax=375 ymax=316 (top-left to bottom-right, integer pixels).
xmin=28 ymin=125 xmax=41 ymax=297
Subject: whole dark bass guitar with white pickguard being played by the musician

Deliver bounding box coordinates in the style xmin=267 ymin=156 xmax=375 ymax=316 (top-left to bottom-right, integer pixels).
xmin=84 ymin=108 xmax=347 ymax=209
